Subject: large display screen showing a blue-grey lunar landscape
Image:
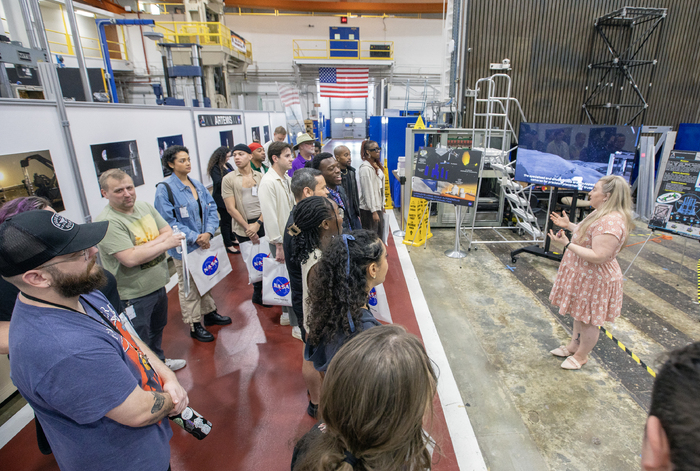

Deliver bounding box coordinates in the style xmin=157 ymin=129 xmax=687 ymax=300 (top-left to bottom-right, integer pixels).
xmin=515 ymin=123 xmax=639 ymax=191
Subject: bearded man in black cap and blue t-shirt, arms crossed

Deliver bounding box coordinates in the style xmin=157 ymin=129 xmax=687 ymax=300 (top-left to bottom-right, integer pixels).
xmin=0 ymin=211 xmax=189 ymax=471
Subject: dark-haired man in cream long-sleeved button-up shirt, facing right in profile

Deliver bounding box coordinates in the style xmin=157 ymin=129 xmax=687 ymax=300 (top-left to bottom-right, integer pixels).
xmin=258 ymin=142 xmax=298 ymax=327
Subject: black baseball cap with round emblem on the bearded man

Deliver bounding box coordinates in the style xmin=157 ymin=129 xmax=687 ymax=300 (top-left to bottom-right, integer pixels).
xmin=0 ymin=210 xmax=109 ymax=277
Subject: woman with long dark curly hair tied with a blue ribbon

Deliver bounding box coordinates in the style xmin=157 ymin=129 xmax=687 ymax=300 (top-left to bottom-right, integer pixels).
xmin=304 ymin=229 xmax=389 ymax=372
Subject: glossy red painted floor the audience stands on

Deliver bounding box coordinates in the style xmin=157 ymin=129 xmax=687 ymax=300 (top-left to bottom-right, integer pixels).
xmin=0 ymin=232 xmax=458 ymax=471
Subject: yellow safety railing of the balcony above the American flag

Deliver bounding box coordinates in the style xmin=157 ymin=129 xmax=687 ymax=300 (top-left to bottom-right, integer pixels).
xmin=292 ymin=39 xmax=394 ymax=61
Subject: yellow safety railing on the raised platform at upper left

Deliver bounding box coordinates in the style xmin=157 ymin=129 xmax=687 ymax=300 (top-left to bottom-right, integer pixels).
xmin=155 ymin=21 xmax=253 ymax=61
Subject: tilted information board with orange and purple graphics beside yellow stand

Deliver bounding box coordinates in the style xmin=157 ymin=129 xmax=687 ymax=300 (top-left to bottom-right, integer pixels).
xmin=411 ymin=147 xmax=482 ymax=206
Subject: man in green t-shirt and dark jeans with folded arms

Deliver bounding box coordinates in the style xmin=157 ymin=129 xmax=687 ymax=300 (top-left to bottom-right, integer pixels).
xmin=96 ymin=169 xmax=194 ymax=370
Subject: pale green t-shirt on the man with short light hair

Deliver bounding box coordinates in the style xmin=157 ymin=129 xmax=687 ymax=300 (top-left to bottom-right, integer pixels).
xmin=96 ymin=201 xmax=170 ymax=301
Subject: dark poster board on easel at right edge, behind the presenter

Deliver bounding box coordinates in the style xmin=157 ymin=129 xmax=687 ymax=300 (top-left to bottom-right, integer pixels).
xmin=649 ymin=150 xmax=700 ymax=239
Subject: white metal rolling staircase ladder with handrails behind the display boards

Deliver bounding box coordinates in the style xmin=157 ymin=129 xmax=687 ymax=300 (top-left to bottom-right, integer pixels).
xmin=465 ymin=74 xmax=544 ymax=250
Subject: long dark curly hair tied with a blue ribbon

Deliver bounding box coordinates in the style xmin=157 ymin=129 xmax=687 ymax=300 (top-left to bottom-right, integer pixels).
xmin=308 ymin=229 xmax=384 ymax=345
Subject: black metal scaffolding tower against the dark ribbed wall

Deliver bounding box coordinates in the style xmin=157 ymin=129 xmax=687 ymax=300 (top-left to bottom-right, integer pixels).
xmin=581 ymin=7 xmax=667 ymax=125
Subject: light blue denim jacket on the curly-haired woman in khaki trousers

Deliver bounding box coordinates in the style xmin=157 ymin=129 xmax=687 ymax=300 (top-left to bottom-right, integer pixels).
xmin=153 ymin=174 xmax=219 ymax=260
